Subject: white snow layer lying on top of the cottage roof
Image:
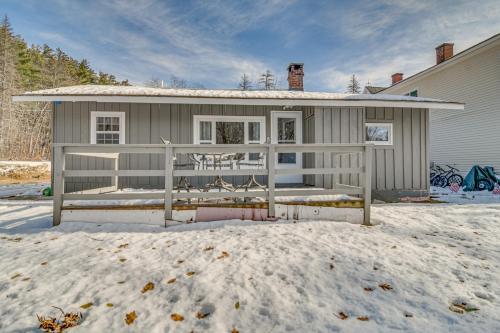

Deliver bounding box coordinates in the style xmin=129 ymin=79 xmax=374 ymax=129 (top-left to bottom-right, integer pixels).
xmin=18 ymin=85 xmax=454 ymax=102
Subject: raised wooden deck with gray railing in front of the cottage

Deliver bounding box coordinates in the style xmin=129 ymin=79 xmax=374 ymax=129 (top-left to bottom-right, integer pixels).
xmin=53 ymin=143 xmax=373 ymax=225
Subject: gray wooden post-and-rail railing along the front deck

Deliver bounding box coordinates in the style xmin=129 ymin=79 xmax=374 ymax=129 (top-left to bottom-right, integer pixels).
xmin=53 ymin=143 xmax=373 ymax=225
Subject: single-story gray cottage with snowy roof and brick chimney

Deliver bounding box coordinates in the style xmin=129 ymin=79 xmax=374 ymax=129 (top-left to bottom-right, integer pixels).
xmin=14 ymin=63 xmax=463 ymax=223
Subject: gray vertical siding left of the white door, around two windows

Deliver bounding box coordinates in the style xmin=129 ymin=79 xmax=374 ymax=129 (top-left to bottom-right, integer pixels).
xmin=53 ymin=102 xmax=312 ymax=192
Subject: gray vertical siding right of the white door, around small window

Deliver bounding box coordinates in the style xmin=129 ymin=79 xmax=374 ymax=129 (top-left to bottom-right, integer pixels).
xmin=315 ymin=108 xmax=429 ymax=190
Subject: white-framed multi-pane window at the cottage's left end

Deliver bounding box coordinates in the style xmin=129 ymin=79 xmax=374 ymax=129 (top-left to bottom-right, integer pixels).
xmin=90 ymin=111 xmax=125 ymax=144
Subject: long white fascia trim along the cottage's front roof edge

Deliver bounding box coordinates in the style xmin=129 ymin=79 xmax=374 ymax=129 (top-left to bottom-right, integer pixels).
xmin=12 ymin=95 xmax=464 ymax=110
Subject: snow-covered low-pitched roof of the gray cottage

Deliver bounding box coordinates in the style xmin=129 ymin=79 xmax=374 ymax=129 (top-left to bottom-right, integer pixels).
xmin=14 ymin=85 xmax=462 ymax=108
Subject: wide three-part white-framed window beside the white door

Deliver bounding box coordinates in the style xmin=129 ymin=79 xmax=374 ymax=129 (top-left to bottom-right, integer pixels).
xmin=193 ymin=116 xmax=266 ymax=161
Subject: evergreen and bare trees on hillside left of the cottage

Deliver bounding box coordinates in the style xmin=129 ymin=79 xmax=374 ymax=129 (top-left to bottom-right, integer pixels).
xmin=0 ymin=16 xmax=129 ymax=159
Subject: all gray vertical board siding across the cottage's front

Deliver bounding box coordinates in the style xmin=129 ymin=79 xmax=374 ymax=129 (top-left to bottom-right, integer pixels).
xmin=53 ymin=102 xmax=429 ymax=192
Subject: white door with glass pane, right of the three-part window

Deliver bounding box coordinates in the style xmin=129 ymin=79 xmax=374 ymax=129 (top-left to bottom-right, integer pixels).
xmin=271 ymin=111 xmax=303 ymax=183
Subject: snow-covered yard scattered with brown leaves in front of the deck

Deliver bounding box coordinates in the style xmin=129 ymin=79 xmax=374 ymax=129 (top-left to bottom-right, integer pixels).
xmin=0 ymin=201 xmax=500 ymax=333
